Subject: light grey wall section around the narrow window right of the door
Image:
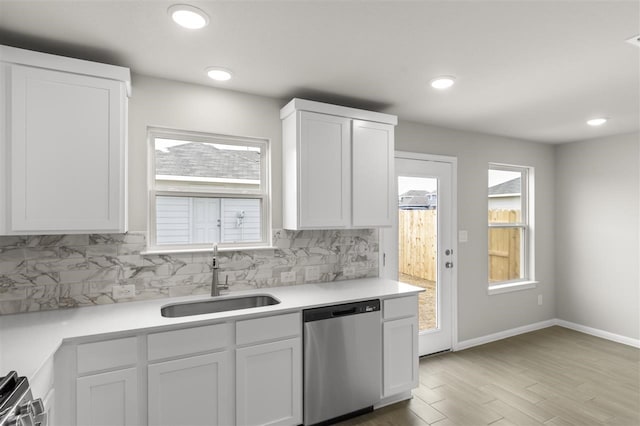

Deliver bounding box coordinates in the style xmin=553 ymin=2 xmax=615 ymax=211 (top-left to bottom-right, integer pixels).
xmin=396 ymin=121 xmax=555 ymax=341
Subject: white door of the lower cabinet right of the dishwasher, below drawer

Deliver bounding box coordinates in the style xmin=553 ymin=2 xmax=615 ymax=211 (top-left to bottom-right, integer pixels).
xmin=382 ymin=317 xmax=418 ymax=397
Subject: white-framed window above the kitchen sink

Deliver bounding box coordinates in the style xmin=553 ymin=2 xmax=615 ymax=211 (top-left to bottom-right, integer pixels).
xmin=149 ymin=129 xmax=270 ymax=250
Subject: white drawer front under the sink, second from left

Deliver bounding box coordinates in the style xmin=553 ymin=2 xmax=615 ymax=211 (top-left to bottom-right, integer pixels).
xmin=147 ymin=324 xmax=232 ymax=361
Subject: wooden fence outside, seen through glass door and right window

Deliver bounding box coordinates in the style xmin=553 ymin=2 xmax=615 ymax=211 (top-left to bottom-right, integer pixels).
xmin=398 ymin=210 xmax=520 ymax=282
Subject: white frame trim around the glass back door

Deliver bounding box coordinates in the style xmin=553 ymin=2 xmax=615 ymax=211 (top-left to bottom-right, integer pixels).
xmin=378 ymin=151 xmax=459 ymax=352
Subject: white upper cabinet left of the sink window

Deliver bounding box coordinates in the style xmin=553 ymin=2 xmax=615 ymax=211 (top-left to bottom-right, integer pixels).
xmin=0 ymin=46 xmax=130 ymax=235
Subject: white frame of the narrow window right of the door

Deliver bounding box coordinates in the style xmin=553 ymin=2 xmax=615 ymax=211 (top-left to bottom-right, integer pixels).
xmin=485 ymin=163 xmax=537 ymax=295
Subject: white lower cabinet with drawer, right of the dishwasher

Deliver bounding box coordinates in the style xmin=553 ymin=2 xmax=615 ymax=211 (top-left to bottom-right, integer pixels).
xmin=382 ymin=296 xmax=419 ymax=398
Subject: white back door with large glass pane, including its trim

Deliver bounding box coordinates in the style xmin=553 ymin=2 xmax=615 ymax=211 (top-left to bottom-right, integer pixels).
xmin=381 ymin=152 xmax=456 ymax=355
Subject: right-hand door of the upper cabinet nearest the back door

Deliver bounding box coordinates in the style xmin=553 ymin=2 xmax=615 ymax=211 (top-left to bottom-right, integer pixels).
xmin=351 ymin=120 xmax=394 ymax=227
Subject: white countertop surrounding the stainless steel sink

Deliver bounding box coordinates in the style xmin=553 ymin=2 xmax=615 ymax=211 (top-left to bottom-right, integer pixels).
xmin=0 ymin=278 xmax=424 ymax=379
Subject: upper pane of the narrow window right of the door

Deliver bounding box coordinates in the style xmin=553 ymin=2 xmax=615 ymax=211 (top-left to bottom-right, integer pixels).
xmin=488 ymin=169 xmax=522 ymax=223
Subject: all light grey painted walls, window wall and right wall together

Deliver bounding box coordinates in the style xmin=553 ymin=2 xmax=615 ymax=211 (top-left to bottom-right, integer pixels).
xmin=129 ymin=74 xmax=640 ymax=340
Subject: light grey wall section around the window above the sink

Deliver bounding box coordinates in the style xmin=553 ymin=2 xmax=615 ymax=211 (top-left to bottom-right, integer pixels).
xmin=129 ymin=74 xmax=285 ymax=231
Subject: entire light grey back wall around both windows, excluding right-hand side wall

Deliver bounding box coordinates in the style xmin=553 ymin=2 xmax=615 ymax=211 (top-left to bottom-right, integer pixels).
xmin=129 ymin=74 xmax=555 ymax=340
